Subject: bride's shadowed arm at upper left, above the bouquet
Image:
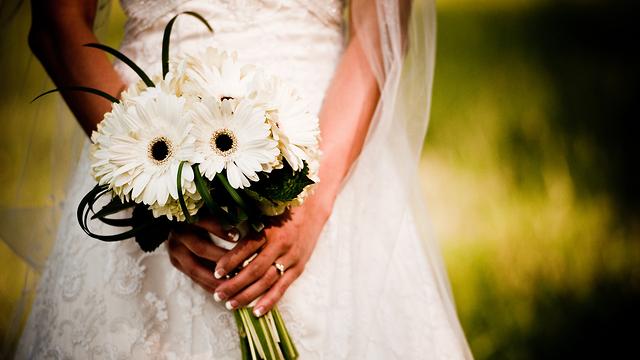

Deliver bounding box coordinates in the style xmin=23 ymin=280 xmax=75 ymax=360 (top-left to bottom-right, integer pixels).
xmin=29 ymin=0 xmax=124 ymax=134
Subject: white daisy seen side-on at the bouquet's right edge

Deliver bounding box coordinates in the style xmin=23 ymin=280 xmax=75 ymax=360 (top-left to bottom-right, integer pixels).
xmin=266 ymin=76 xmax=320 ymax=171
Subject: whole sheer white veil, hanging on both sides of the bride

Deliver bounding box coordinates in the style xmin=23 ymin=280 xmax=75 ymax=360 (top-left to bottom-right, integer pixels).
xmin=0 ymin=0 xmax=472 ymax=359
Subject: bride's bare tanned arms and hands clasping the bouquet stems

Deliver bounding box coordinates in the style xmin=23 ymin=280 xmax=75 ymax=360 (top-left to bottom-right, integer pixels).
xmin=29 ymin=0 xmax=380 ymax=315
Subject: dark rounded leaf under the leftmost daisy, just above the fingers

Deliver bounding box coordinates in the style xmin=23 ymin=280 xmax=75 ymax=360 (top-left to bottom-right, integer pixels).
xmin=131 ymin=204 xmax=173 ymax=252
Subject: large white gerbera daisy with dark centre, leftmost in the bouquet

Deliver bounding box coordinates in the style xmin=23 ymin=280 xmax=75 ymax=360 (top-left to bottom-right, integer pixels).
xmin=92 ymin=91 xmax=201 ymax=219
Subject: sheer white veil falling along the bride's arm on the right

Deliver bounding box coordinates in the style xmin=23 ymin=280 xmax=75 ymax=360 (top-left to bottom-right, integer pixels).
xmin=340 ymin=0 xmax=473 ymax=359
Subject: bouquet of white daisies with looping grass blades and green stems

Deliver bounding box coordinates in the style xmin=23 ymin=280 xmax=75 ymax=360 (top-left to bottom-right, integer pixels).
xmin=36 ymin=12 xmax=321 ymax=359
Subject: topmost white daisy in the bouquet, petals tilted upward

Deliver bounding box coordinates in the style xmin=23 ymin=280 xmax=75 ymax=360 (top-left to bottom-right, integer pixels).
xmin=171 ymin=47 xmax=258 ymax=102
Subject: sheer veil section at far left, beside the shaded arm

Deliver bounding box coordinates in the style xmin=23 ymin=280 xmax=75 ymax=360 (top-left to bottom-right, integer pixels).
xmin=0 ymin=0 xmax=111 ymax=359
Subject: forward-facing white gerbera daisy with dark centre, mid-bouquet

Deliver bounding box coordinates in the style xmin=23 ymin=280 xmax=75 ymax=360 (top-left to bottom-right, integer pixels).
xmin=193 ymin=97 xmax=280 ymax=189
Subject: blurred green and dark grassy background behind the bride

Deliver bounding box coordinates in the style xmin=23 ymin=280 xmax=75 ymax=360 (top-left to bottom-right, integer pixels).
xmin=0 ymin=0 xmax=640 ymax=359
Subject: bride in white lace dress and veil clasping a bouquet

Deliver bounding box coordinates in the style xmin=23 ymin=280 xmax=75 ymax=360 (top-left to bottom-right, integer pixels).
xmin=11 ymin=0 xmax=471 ymax=359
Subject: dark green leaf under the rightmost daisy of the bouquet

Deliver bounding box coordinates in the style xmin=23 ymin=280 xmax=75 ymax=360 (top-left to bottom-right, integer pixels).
xmin=251 ymin=161 xmax=315 ymax=203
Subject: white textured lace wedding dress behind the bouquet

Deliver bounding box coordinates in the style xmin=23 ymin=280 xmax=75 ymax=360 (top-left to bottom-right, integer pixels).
xmin=17 ymin=0 xmax=471 ymax=360
